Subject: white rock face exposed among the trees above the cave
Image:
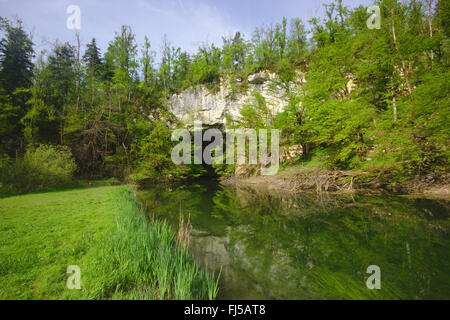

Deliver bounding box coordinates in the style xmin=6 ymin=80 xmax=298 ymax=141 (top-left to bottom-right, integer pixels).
xmin=166 ymin=71 xmax=304 ymax=127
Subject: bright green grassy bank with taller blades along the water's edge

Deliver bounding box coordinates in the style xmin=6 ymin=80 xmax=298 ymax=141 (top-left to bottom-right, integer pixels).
xmin=0 ymin=186 xmax=217 ymax=299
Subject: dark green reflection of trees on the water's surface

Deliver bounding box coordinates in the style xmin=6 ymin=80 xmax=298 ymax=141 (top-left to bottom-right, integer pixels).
xmin=209 ymin=189 xmax=450 ymax=298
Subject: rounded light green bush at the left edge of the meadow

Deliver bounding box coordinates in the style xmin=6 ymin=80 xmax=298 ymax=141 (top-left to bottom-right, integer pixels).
xmin=0 ymin=145 xmax=76 ymax=195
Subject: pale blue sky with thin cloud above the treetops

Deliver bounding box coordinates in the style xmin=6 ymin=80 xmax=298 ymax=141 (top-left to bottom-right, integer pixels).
xmin=0 ymin=0 xmax=374 ymax=60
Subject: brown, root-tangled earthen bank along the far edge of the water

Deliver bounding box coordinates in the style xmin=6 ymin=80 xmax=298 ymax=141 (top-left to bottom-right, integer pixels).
xmin=220 ymin=166 xmax=450 ymax=199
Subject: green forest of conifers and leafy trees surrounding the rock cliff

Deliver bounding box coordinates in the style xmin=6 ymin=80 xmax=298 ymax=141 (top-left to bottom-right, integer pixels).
xmin=0 ymin=0 xmax=450 ymax=195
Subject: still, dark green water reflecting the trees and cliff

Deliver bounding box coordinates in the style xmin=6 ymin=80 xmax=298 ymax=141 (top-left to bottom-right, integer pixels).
xmin=138 ymin=182 xmax=450 ymax=299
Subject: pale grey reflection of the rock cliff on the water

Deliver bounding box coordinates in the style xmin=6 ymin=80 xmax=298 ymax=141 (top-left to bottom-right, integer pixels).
xmin=191 ymin=228 xmax=312 ymax=299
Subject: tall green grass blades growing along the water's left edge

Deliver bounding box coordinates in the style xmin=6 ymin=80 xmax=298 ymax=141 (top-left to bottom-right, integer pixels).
xmin=85 ymin=187 xmax=218 ymax=300
